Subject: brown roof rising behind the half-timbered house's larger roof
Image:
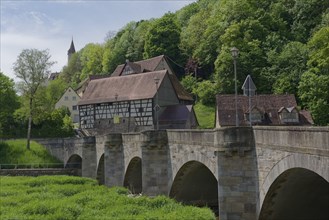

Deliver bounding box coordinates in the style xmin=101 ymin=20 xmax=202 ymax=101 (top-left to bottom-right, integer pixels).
xmin=111 ymin=55 xmax=165 ymax=76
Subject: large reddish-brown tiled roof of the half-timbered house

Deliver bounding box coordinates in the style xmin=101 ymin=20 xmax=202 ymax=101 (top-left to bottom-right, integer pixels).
xmin=78 ymin=70 xmax=168 ymax=105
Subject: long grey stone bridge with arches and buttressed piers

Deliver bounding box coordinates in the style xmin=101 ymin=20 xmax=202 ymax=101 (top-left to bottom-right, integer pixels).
xmin=34 ymin=126 xmax=329 ymax=220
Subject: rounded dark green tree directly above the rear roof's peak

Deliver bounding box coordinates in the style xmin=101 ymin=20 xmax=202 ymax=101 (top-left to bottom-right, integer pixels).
xmin=144 ymin=13 xmax=181 ymax=62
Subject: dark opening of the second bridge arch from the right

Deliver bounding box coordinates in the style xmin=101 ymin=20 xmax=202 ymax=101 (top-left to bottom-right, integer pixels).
xmin=169 ymin=160 xmax=218 ymax=213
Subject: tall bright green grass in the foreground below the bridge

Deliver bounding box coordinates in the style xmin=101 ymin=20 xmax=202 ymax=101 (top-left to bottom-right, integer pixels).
xmin=0 ymin=176 xmax=215 ymax=220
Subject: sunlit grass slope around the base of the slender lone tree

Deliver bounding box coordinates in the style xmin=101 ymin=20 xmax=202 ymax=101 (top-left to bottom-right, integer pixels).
xmin=0 ymin=139 xmax=61 ymax=167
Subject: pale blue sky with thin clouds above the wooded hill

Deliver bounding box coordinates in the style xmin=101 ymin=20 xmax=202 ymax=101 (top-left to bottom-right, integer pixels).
xmin=0 ymin=0 xmax=195 ymax=81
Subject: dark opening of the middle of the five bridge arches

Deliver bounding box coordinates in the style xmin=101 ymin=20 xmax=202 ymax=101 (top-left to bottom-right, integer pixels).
xmin=123 ymin=157 xmax=143 ymax=194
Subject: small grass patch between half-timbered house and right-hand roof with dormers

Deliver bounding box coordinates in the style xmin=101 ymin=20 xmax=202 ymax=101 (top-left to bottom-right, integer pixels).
xmin=194 ymin=102 xmax=216 ymax=128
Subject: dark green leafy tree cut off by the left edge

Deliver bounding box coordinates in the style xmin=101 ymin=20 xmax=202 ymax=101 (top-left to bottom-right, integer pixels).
xmin=0 ymin=72 xmax=19 ymax=137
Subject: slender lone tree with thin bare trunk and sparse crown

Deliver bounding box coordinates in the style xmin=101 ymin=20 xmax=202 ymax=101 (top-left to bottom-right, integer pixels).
xmin=13 ymin=49 xmax=54 ymax=149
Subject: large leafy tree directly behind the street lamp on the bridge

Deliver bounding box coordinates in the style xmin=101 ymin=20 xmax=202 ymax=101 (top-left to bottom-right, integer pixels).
xmin=215 ymin=19 xmax=272 ymax=93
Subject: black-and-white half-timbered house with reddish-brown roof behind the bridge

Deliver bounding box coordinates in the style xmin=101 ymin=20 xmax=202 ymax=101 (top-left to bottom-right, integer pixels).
xmin=79 ymin=68 xmax=197 ymax=134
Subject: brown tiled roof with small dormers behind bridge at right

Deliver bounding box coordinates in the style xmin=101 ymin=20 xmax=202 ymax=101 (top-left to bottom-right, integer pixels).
xmin=216 ymin=95 xmax=313 ymax=126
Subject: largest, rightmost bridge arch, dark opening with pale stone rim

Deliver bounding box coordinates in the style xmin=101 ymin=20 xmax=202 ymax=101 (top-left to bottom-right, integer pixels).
xmin=259 ymin=154 xmax=329 ymax=220
